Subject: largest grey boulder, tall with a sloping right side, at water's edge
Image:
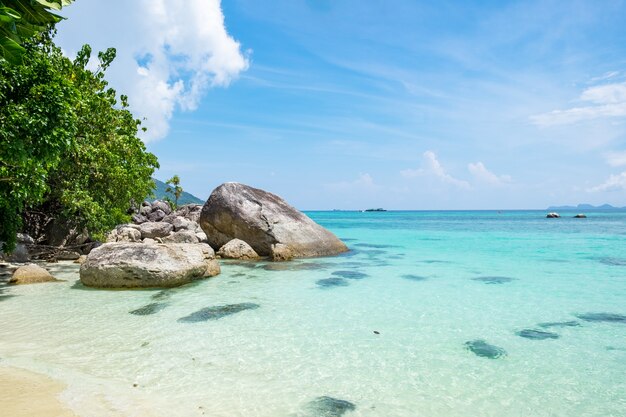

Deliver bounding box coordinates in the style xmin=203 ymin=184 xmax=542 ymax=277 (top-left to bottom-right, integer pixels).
xmin=200 ymin=182 xmax=348 ymax=260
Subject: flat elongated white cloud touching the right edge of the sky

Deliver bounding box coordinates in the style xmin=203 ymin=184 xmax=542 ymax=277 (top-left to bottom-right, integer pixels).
xmin=530 ymin=82 xmax=626 ymax=127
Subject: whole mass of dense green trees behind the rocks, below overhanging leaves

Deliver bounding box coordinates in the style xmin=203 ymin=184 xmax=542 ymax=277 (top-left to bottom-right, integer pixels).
xmin=0 ymin=32 xmax=158 ymax=250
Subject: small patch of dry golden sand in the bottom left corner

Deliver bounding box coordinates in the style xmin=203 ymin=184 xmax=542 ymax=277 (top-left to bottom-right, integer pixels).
xmin=0 ymin=366 xmax=79 ymax=417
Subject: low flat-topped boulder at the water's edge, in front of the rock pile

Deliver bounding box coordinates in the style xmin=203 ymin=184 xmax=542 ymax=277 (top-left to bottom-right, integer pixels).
xmin=80 ymin=243 xmax=220 ymax=288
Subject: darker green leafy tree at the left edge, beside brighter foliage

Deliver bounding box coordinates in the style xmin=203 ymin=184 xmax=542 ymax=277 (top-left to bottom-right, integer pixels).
xmin=0 ymin=30 xmax=79 ymax=251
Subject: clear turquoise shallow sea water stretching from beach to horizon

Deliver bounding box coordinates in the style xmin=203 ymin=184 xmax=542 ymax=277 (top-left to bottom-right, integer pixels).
xmin=0 ymin=211 xmax=626 ymax=417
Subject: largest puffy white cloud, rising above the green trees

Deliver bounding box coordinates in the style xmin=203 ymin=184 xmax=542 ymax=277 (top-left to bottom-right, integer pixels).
xmin=59 ymin=0 xmax=249 ymax=141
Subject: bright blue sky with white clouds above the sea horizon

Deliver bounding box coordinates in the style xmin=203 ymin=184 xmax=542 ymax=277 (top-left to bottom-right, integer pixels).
xmin=57 ymin=0 xmax=626 ymax=210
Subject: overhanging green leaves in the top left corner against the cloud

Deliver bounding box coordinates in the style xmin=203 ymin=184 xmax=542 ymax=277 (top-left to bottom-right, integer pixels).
xmin=0 ymin=0 xmax=73 ymax=64
